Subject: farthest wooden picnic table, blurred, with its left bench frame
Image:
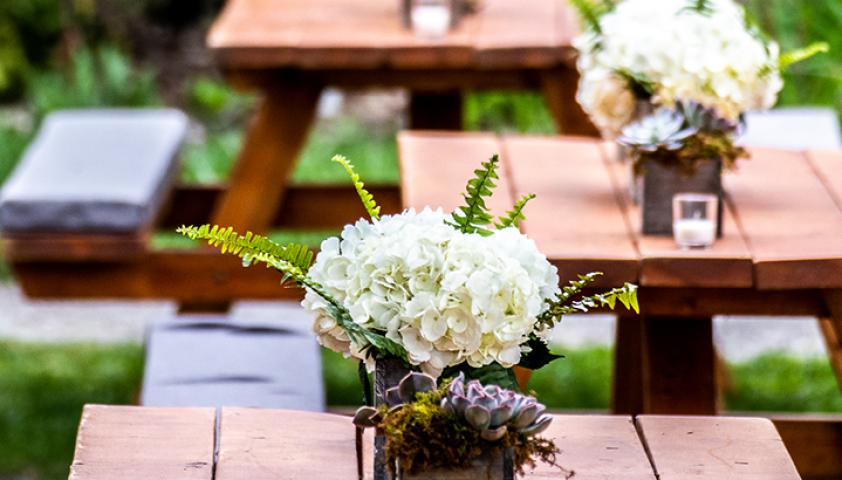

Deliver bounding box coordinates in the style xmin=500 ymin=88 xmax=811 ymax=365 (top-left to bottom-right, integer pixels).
xmin=3 ymin=0 xmax=595 ymax=310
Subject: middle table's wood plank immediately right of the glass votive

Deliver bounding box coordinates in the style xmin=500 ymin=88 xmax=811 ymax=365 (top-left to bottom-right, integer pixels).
xmin=723 ymin=149 xmax=842 ymax=289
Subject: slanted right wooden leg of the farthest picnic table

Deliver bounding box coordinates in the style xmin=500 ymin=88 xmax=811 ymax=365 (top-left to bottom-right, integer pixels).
xmin=541 ymin=68 xmax=600 ymax=137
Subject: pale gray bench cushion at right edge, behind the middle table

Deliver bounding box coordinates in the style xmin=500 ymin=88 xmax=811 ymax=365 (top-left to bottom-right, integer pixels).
xmin=740 ymin=107 xmax=842 ymax=150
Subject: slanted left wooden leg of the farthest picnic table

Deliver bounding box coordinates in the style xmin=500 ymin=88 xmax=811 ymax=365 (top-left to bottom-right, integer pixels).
xmin=212 ymin=82 xmax=329 ymax=233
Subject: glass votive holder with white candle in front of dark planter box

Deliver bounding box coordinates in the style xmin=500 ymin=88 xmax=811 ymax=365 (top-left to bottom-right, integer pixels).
xmin=672 ymin=193 xmax=719 ymax=248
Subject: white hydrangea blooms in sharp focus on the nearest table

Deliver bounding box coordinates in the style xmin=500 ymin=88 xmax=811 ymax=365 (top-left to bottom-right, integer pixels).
xmin=303 ymin=209 xmax=559 ymax=376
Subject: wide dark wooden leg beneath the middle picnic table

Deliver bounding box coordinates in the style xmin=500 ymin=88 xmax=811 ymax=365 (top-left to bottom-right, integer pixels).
xmin=642 ymin=316 xmax=717 ymax=415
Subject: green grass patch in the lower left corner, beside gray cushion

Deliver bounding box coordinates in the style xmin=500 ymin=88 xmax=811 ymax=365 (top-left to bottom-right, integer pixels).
xmin=0 ymin=341 xmax=143 ymax=479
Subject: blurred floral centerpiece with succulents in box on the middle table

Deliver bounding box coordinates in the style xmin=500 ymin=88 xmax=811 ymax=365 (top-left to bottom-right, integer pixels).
xmin=573 ymin=0 xmax=827 ymax=234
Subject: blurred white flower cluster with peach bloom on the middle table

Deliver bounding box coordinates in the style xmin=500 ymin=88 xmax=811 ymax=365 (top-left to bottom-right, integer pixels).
xmin=574 ymin=0 xmax=783 ymax=137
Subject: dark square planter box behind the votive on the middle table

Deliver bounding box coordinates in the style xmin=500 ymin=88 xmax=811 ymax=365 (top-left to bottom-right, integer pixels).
xmin=641 ymin=159 xmax=723 ymax=237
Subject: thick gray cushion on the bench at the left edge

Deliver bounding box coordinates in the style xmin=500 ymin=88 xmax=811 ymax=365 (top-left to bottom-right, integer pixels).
xmin=0 ymin=109 xmax=187 ymax=232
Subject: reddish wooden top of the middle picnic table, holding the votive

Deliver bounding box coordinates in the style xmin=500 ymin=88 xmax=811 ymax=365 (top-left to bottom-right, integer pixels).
xmin=398 ymin=132 xmax=842 ymax=290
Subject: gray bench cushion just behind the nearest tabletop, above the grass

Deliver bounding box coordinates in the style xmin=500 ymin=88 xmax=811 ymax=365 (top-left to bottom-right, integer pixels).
xmin=141 ymin=314 xmax=325 ymax=411
